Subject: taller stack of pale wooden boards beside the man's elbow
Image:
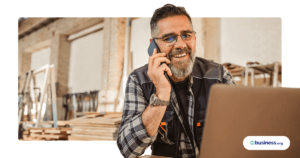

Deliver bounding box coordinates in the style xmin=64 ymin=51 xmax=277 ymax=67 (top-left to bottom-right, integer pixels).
xmin=69 ymin=113 xmax=122 ymax=141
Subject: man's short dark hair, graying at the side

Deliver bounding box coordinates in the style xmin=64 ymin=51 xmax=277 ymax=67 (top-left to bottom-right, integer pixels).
xmin=150 ymin=3 xmax=193 ymax=38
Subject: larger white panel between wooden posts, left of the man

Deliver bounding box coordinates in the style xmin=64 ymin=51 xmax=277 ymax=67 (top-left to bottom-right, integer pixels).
xmin=68 ymin=30 xmax=103 ymax=93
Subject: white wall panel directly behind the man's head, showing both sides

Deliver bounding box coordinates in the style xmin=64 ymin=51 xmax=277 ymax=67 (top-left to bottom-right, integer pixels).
xmin=130 ymin=17 xmax=204 ymax=69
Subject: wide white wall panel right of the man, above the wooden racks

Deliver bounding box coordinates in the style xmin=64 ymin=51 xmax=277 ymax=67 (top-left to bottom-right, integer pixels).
xmin=220 ymin=17 xmax=282 ymax=66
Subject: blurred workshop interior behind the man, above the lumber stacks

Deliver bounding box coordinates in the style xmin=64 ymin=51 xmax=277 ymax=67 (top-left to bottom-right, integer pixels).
xmin=17 ymin=17 xmax=282 ymax=126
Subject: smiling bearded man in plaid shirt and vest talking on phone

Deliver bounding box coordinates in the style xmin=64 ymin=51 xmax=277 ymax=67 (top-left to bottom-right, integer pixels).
xmin=117 ymin=4 xmax=235 ymax=157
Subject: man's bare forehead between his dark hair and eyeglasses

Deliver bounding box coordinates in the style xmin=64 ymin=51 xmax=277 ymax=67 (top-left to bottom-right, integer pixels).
xmin=157 ymin=15 xmax=192 ymax=36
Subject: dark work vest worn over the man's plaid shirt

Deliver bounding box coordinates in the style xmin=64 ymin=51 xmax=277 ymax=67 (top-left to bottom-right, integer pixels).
xmin=134 ymin=57 xmax=224 ymax=157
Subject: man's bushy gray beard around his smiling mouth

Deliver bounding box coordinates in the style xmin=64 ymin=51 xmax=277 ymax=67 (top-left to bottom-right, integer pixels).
xmin=169 ymin=49 xmax=196 ymax=78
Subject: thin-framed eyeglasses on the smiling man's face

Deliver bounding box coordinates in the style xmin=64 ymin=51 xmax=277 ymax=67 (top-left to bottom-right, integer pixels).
xmin=153 ymin=31 xmax=196 ymax=47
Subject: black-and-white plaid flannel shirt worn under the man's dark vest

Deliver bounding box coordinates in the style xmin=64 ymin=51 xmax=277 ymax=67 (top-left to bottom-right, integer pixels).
xmin=116 ymin=66 xmax=235 ymax=158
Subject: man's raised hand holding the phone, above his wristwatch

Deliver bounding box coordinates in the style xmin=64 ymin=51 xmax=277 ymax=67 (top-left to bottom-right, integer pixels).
xmin=147 ymin=48 xmax=172 ymax=101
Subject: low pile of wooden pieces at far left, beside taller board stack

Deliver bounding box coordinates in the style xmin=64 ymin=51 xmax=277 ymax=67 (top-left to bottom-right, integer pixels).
xmin=23 ymin=127 xmax=72 ymax=141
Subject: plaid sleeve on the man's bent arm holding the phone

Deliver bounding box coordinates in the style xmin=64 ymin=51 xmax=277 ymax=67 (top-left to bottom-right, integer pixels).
xmin=116 ymin=74 xmax=157 ymax=158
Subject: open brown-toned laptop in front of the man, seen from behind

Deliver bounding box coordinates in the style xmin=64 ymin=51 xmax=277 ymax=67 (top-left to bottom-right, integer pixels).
xmin=200 ymin=84 xmax=300 ymax=158
